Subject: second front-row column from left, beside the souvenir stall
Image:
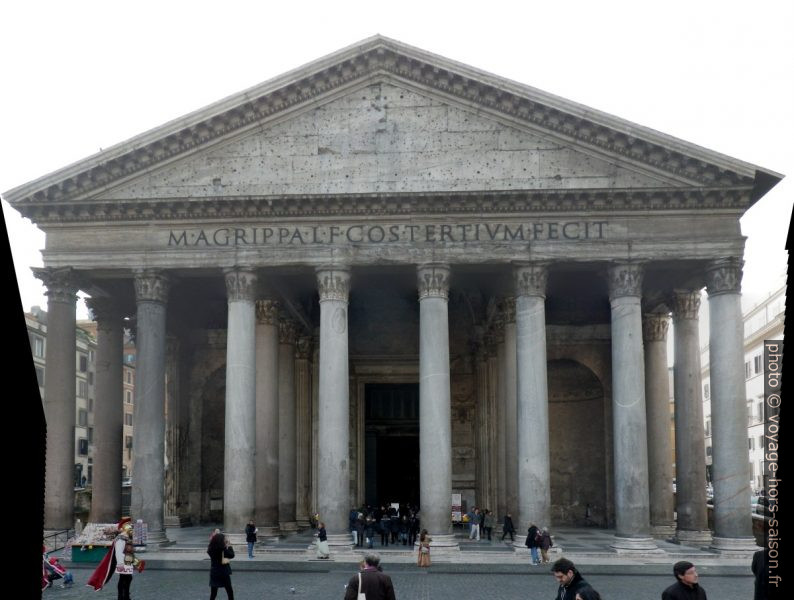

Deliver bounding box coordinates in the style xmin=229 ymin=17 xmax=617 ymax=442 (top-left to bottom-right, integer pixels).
xmin=130 ymin=271 xmax=168 ymax=545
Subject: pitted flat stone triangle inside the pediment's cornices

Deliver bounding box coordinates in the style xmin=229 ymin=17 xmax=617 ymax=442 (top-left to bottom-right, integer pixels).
xmin=98 ymin=81 xmax=676 ymax=200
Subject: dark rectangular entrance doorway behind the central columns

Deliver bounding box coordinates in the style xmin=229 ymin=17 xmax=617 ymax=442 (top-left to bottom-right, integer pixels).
xmin=364 ymin=383 xmax=419 ymax=506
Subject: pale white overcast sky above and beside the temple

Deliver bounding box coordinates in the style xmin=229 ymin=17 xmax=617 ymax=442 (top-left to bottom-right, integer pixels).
xmin=0 ymin=0 xmax=794 ymax=316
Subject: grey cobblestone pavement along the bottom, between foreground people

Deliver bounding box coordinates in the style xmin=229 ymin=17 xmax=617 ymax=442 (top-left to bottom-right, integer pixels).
xmin=43 ymin=565 xmax=753 ymax=600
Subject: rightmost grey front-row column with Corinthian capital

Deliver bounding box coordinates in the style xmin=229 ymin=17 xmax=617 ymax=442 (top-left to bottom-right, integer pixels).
xmin=708 ymin=259 xmax=755 ymax=550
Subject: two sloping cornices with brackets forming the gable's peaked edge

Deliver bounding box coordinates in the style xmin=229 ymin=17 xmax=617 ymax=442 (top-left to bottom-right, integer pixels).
xmin=5 ymin=36 xmax=780 ymax=211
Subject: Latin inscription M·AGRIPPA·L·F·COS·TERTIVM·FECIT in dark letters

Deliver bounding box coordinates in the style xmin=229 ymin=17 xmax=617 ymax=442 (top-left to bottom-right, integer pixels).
xmin=168 ymin=221 xmax=609 ymax=247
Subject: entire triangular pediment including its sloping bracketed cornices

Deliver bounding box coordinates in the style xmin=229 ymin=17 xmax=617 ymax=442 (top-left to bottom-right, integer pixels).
xmin=4 ymin=36 xmax=781 ymax=216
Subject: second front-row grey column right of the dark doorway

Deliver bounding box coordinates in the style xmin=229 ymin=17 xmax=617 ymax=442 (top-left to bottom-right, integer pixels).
xmin=515 ymin=265 xmax=551 ymax=531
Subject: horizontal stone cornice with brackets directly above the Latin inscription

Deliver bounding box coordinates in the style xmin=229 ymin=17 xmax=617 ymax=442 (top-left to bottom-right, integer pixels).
xmin=15 ymin=188 xmax=752 ymax=225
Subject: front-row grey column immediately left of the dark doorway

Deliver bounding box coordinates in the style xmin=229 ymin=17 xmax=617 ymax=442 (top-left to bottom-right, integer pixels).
xmin=317 ymin=268 xmax=350 ymax=535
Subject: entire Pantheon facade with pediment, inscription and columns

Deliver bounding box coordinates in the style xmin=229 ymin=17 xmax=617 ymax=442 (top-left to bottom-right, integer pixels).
xmin=4 ymin=36 xmax=781 ymax=551
